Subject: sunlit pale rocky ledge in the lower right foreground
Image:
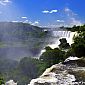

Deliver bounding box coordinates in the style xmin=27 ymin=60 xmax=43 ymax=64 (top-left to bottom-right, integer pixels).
xmin=28 ymin=58 xmax=85 ymax=85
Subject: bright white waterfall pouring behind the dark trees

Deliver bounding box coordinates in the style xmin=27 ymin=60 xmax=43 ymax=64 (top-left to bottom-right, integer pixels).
xmin=48 ymin=31 xmax=76 ymax=49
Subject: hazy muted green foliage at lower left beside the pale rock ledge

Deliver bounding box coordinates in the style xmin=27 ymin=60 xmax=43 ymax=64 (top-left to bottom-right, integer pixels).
xmin=0 ymin=57 xmax=47 ymax=85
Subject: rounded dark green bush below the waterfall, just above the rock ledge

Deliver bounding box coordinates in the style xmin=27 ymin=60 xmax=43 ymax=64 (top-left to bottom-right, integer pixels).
xmin=40 ymin=48 xmax=65 ymax=67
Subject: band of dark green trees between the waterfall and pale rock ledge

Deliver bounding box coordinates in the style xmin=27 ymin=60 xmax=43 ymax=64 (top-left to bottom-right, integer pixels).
xmin=40 ymin=25 xmax=85 ymax=66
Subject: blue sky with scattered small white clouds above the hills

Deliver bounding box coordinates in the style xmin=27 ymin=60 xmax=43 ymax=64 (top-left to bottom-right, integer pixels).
xmin=0 ymin=0 xmax=85 ymax=27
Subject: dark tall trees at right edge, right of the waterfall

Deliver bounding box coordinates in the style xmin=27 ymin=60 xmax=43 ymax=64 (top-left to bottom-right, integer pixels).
xmin=68 ymin=25 xmax=85 ymax=57
